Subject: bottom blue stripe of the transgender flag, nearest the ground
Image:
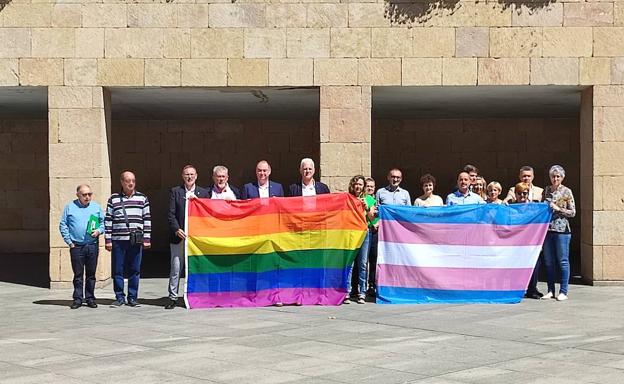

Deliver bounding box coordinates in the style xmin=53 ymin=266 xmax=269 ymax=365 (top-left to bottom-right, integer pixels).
xmin=377 ymin=286 xmax=524 ymax=304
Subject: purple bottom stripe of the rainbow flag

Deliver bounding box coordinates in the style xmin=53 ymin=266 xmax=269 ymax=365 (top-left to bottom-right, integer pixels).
xmin=187 ymin=288 xmax=347 ymax=308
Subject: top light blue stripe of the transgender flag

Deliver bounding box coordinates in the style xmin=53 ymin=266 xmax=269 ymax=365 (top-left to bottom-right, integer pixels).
xmin=379 ymin=203 xmax=551 ymax=225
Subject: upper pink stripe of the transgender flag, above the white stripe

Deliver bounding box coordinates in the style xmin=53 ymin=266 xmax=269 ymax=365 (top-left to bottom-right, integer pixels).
xmin=379 ymin=220 xmax=548 ymax=246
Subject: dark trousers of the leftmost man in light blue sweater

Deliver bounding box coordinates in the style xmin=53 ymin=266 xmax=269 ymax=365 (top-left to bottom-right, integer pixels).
xmin=69 ymin=243 xmax=98 ymax=301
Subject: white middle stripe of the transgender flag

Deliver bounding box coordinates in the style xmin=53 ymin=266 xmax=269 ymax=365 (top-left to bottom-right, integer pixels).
xmin=377 ymin=241 xmax=542 ymax=268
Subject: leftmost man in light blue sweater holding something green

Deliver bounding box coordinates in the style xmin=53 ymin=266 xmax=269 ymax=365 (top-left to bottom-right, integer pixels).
xmin=59 ymin=184 xmax=104 ymax=309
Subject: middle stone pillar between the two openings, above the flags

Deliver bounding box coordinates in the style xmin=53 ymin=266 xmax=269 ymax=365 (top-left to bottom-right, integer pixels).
xmin=319 ymin=86 xmax=371 ymax=192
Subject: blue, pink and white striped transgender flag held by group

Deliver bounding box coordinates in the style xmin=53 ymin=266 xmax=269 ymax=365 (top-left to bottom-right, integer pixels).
xmin=377 ymin=203 xmax=551 ymax=304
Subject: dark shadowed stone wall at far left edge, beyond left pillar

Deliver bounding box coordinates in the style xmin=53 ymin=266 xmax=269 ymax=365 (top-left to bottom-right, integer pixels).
xmin=0 ymin=120 xmax=48 ymax=253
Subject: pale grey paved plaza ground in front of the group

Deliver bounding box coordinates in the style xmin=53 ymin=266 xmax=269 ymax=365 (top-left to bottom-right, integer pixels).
xmin=0 ymin=279 xmax=624 ymax=384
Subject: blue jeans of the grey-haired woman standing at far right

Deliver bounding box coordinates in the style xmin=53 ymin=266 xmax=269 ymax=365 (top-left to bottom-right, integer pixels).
xmin=544 ymin=231 xmax=572 ymax=295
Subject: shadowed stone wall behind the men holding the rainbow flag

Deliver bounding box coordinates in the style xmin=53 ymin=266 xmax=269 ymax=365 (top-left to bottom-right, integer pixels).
xmin=111 ymin=119 xmax=319 ymax=251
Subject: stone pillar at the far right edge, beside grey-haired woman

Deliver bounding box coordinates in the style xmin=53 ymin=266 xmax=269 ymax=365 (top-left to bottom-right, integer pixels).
xmin=581 ymin=85 xmax=624 ymax=284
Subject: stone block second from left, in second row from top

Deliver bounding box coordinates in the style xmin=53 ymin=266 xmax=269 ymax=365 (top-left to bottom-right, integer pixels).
xmin=31 ymin=28 xmax=76 ymax=57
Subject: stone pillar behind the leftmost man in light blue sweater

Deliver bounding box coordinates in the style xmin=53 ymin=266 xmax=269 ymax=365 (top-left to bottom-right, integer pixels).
xmin=48 ymin=86 xmax=111 ymax=288
